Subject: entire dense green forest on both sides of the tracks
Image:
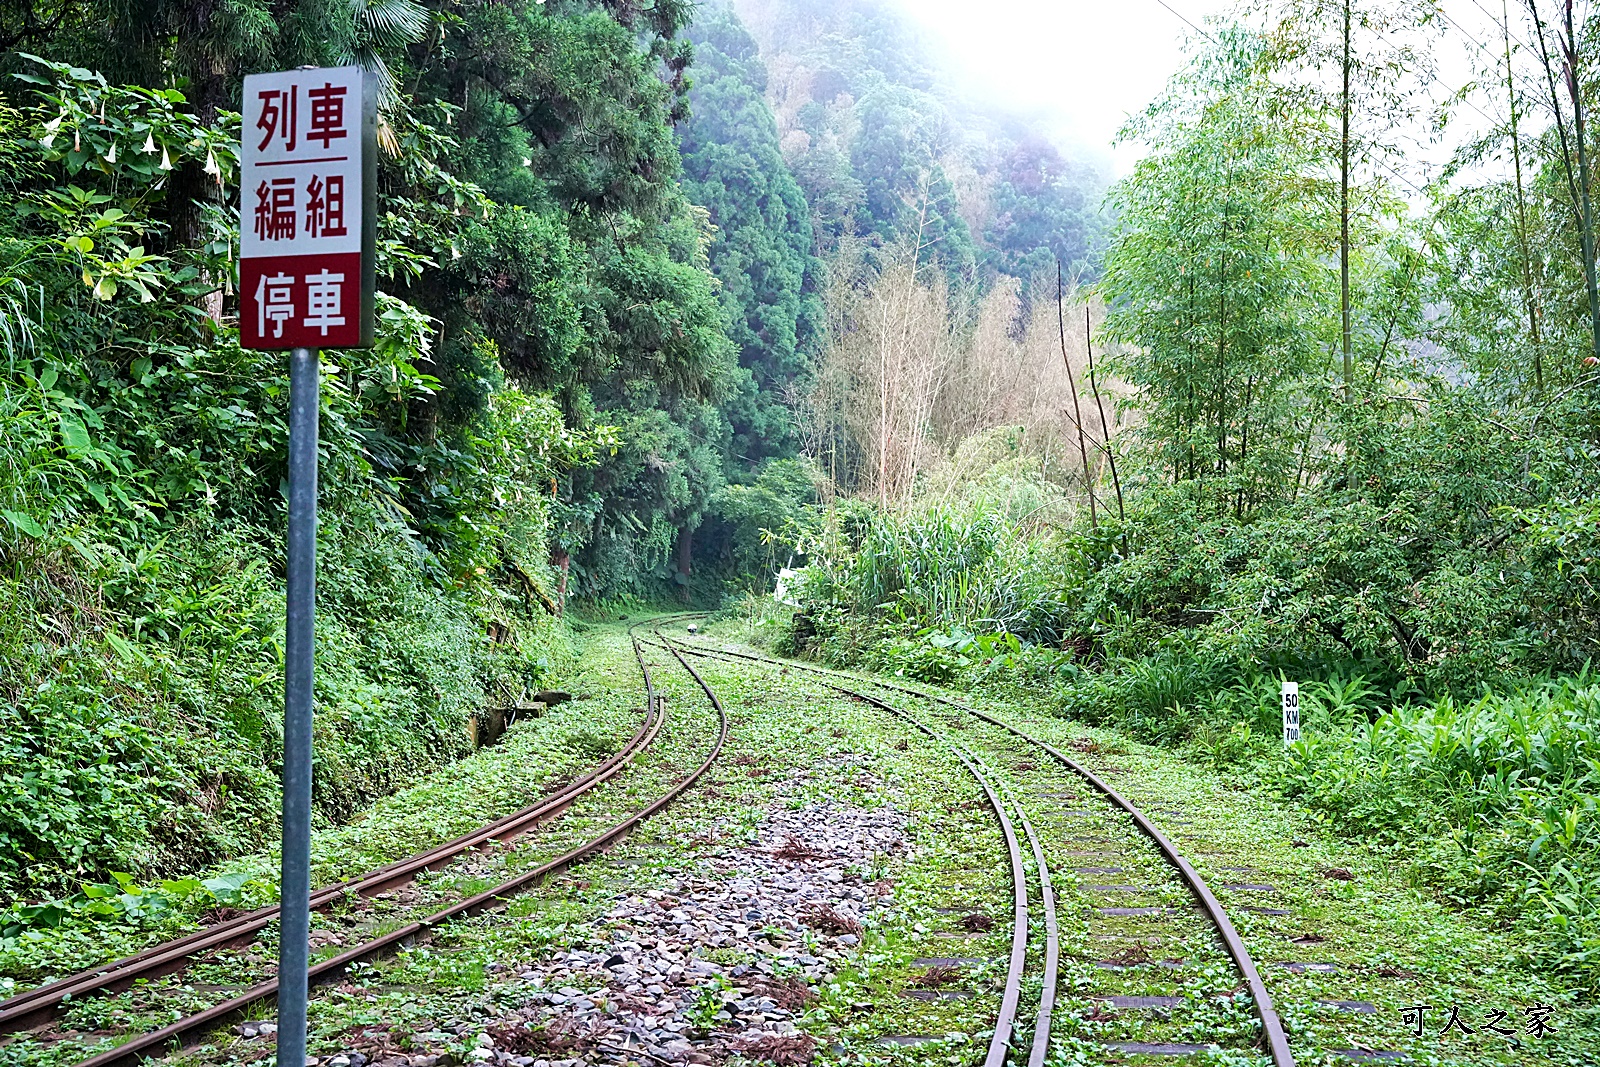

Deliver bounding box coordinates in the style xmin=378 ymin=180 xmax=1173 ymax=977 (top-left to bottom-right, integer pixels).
xmin=0 ymin=0 xmax=1600 ymax=1004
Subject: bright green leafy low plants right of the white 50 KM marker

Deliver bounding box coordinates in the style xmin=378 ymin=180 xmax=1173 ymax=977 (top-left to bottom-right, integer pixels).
xmin=1278 ymin=673 xmax=1600 ymax=984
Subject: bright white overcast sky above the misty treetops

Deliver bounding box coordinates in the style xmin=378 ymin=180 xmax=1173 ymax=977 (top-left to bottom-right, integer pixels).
xmin=888 ymin=0 xmax=1533 ymax=184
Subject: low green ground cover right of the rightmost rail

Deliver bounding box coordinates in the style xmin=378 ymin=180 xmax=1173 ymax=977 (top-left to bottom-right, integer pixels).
xmin=723 ymin=627 xmax=1600 ymax=1064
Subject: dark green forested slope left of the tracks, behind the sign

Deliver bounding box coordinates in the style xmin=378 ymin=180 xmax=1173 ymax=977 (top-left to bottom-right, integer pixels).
xmin=0 ymin=0 xmax=1094 ymax=901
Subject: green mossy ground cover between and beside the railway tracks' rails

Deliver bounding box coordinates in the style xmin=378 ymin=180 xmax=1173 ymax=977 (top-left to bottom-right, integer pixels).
xmin=0 ymin=622 xmax=1600 ymax=1067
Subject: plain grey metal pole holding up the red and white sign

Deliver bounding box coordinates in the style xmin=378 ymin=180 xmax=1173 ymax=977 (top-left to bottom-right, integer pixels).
xmin=278 ymin=349 xmax=320 ymax=1067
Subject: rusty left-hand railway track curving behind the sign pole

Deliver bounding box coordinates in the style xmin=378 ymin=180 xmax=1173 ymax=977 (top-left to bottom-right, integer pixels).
xmin=0 ymin=627 xmax=728 ymax=1067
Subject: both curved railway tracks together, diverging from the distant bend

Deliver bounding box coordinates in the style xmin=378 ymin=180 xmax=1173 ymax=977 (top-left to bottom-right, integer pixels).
xmin=15 ymin=613 xmax=1294 ymax=1067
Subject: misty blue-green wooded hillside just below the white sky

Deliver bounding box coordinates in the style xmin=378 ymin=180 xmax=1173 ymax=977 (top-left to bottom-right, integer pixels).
xmin=734 ymin=0 xmax=1104 ymax=285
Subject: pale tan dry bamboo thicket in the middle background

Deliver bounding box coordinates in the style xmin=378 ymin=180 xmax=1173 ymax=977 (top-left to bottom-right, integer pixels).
xmin=798 ymin=248 xmax=1126 ymax=518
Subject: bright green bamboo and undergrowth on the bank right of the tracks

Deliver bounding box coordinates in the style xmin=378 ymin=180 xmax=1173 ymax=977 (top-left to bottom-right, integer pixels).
xmin=768 ymin=3 xmax=1600 ymax=982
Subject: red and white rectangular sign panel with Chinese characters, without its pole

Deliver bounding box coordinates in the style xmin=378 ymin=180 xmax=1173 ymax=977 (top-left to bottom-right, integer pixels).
xmin=238 ymin=67 xmax=376 ymax=349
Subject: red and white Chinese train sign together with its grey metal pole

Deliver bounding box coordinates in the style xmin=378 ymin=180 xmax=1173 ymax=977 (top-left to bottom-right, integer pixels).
xmin=238 ymin=67 xmax=378 ymax=1067
